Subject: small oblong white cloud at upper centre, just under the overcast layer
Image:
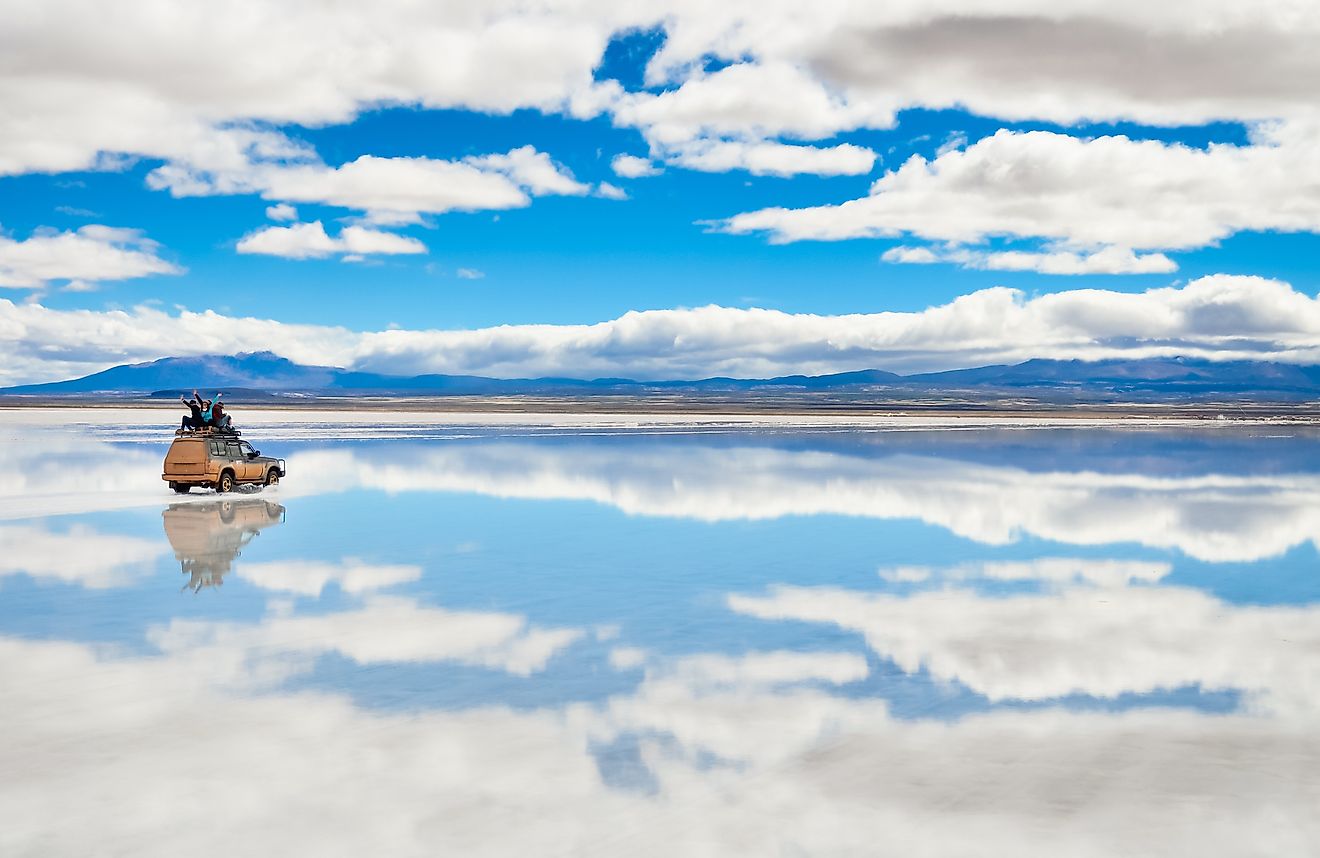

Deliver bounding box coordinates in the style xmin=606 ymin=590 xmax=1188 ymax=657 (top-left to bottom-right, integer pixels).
xmin=669 ymin=140 xmax=875 ymax=176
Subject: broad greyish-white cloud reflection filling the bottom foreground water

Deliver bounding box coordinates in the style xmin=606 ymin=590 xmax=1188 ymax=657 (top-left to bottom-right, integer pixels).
xmin=0 ymin=630 xmax=1320 ymax=857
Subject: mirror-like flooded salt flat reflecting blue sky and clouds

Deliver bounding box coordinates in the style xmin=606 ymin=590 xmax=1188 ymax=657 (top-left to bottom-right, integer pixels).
xmin=0 ymin=412 xmax=1320 ymax=858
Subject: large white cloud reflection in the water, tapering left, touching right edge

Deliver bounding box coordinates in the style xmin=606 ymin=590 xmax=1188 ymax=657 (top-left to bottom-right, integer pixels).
xmin=729 ymin=562 xmax=1320 ymax=713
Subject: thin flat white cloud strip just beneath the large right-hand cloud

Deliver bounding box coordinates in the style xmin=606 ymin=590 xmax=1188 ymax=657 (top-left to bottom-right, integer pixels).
xmin=880 ymin=246 xmax=1177 ymax=275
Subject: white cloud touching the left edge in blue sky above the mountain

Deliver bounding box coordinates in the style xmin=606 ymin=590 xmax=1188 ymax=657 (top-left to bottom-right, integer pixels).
xmin=0 ymin=224 xmax=183 ymax=289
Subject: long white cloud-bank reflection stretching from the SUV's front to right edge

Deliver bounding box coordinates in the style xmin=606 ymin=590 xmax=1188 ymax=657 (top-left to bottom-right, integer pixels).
xmin=290 ymin=441 xmax=1320 ymax=562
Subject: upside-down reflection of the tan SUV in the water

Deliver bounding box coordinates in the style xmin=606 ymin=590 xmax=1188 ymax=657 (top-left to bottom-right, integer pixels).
xmin=161 ymin=499 xmax=285 ymax=593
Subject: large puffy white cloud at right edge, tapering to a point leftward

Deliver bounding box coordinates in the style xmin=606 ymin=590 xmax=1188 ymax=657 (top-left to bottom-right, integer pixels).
xmin=723 ymin=127 xmax=1320 ymax=250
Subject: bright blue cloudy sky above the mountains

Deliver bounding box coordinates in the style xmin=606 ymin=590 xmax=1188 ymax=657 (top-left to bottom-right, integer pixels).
xmin=0 ymin=0 xmax=1320 ymax=384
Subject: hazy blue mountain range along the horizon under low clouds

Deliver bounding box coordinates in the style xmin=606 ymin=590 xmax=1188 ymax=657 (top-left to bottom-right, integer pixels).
xmin=0 ymin=351 xmax=1320 ymax=400
